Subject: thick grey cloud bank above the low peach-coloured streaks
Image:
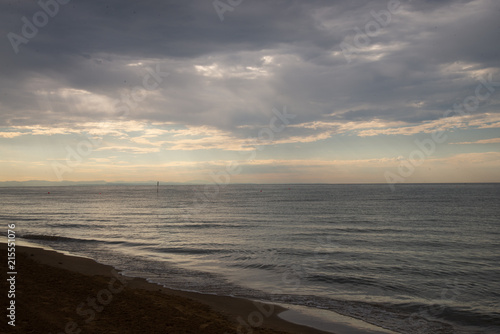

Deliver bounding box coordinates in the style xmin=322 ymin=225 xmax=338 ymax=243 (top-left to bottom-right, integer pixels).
xmin=0 ymin=0 xmax=500 ymax=133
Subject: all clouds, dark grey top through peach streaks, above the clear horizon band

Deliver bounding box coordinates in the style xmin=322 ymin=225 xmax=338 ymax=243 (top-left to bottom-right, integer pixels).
xmin=0 ymin=0 xmax=500 ymax=183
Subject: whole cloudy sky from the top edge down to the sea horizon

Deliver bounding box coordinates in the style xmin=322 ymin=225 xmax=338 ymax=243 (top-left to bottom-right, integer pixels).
xmin=0 ymin=0 xmax=500 ymax=186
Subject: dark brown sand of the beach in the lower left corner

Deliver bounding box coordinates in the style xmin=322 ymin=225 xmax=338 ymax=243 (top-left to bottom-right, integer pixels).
xmin=0 ymin=243 xmax=336 ymax=334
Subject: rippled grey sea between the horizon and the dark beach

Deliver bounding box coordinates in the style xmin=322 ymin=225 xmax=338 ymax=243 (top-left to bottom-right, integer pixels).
xmin=0 ymin=184 xmax=500 ymax=333
